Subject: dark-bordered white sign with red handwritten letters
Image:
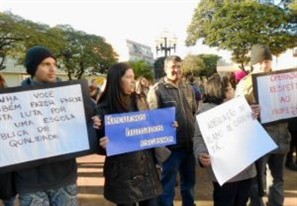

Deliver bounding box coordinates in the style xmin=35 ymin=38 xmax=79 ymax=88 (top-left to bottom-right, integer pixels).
xmin=253 ymin=68 xmax=297 ymax=124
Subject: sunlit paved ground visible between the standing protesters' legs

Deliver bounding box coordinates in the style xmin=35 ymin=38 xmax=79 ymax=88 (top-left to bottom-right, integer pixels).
xmin=78 ymin=155 xmax=297 ymax=206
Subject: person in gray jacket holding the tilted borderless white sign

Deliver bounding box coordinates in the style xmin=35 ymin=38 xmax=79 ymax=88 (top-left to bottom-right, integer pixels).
xmin=194 ymin=76 xmax=256 ymax=206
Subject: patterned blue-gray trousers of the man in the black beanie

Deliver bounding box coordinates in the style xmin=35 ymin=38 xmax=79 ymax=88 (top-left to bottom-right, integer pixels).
xmin=19 ymin=184 xmax=78 ymax=206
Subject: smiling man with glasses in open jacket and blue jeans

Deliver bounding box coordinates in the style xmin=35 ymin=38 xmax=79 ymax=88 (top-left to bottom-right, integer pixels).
xmin=147 ymin=56 xmax=196 ymax=206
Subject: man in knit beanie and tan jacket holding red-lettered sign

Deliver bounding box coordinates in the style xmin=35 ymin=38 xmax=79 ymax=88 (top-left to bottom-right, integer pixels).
xmin=235 ymin=44 xmax=290 ymax=206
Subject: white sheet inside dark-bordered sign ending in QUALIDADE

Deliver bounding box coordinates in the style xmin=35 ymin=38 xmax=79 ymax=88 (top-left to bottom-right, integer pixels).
xmin=0 ymin=85 xmax=89 ymax=167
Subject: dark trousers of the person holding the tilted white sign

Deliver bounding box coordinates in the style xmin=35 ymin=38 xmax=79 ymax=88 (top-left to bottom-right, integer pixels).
xmin=213 ymin=179 xmax=252 ymax=206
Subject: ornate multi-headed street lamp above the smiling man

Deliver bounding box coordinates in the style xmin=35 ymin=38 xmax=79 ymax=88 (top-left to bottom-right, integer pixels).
xmin=156 ymin=31 xmax=177 ymax=58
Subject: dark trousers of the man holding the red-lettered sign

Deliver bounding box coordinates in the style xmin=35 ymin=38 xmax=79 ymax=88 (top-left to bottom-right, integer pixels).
xmin=251 ymin=154 xmax=286 ymax=206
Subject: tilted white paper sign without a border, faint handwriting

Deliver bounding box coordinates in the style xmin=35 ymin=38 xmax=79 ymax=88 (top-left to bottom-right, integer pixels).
xmin=196 ymin=97 xmax=277 ymax=185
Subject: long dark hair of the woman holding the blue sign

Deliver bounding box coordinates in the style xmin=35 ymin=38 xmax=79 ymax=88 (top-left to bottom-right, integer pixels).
xmin=98 ymin=62 xmax=132 ymax=114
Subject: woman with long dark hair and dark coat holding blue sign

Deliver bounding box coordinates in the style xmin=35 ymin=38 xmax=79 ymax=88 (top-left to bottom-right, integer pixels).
xmin=97 ymin=63 xmax=162 ymax=206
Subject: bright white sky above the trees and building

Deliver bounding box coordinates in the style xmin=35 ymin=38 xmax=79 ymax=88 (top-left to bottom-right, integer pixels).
xmin=0 ymin=0 xmax=230 ymax=61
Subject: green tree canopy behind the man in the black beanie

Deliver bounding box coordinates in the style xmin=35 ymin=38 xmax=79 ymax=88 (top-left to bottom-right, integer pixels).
xmin=0 ymin=13 xmax=118 ymax=79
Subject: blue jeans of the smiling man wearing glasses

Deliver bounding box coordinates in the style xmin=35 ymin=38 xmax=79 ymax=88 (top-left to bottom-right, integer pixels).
xmin=160 ymin=150 xmax=196 ymax=206
